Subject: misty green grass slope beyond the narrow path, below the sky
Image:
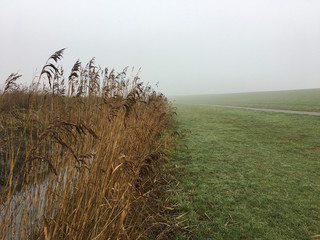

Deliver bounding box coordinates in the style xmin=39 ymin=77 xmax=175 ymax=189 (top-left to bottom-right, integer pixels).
xmin=170 ymin=89 xmax=320 ymax=112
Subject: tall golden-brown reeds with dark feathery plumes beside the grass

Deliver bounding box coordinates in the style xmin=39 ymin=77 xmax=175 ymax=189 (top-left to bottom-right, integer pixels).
xmin=0 ymin=49 xmax=175 ymax=239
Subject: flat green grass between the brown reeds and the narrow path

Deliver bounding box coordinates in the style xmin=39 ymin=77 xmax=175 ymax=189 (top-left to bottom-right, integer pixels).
xmin=172 ymin=105 xmax=320 ymax=239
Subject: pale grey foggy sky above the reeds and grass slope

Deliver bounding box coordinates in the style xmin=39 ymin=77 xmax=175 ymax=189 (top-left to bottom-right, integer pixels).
xmin=0 ymin=0 xmax=320 ymax=95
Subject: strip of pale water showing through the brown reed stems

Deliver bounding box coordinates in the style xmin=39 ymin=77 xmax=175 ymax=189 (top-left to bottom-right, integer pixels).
xmin=0 ymin=146 xmax=95 ymax=240
